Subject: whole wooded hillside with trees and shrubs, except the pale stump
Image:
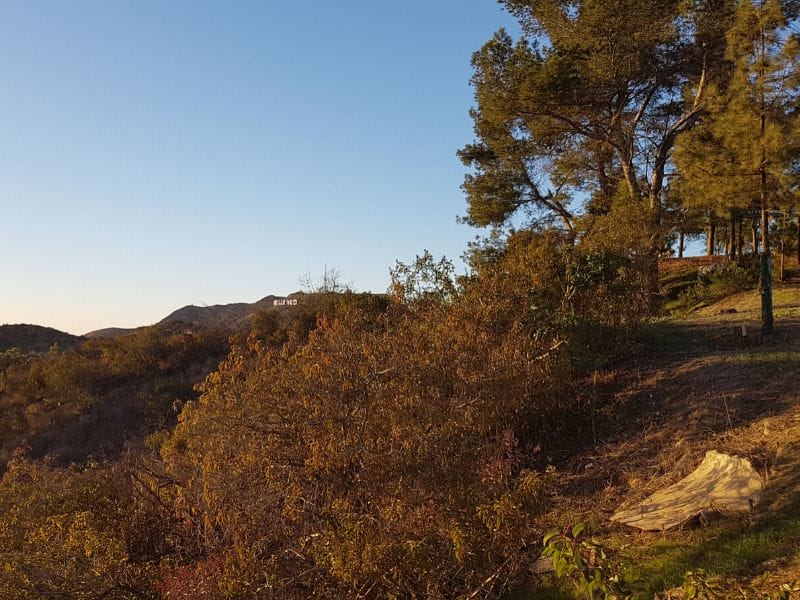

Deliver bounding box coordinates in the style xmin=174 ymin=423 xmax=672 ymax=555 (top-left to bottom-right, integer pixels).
xmin=0 ymin=0 xmax=800 ymax=600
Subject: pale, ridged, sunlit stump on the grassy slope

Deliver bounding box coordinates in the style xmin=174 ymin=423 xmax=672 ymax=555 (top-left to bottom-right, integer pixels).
xmin=611 ymin=450 xmax=761 ymax=531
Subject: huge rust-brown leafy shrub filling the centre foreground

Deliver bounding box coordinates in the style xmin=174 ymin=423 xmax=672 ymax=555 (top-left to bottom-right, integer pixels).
xmin=152 ymin=237 xmax=636 ymax=598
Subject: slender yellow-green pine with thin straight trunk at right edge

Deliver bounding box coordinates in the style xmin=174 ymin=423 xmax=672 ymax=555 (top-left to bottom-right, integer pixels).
xmin=675 ymin=0 xmax=800 ymax=334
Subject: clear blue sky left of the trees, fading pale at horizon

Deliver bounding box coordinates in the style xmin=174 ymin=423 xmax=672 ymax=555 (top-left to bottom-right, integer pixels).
xmin=0 ymin=0 xmax=515 ymax=333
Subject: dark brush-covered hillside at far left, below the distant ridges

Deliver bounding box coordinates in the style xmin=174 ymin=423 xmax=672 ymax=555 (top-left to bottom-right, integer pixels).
xmin=0 ymin=325 xmax=230 ymax=474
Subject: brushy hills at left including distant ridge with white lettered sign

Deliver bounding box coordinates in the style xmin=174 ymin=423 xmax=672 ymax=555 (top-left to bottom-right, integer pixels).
xmin=0 ymin=294 xmax=383 ymax=474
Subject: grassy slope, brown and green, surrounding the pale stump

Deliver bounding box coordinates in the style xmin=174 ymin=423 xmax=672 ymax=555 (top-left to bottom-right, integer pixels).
xmin=533 ymin=286 xmax=800 ymax=599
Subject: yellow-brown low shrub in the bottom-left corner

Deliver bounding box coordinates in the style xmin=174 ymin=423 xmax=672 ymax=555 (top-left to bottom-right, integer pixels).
xmin=0 ymin=456 xmax=163 ymax=600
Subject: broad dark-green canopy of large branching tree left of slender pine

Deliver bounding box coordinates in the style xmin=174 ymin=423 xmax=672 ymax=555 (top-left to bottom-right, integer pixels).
xmin=459 ymin=0 xmax=733 ymax=231
